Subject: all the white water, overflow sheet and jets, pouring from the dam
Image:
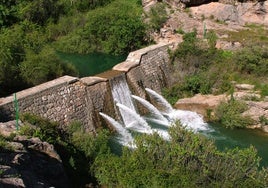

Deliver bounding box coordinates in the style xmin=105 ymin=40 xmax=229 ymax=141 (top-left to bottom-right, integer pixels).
xmin=100 ymin=74 xmax=206 ymax=147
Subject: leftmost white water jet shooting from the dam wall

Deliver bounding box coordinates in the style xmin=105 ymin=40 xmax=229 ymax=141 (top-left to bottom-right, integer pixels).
xmin=99 ymin=112 xmax=134 ymax=147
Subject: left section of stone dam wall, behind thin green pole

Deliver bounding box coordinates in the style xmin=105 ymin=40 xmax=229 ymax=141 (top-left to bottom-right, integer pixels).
xmin=0 ymin=76 xmax=90 ymax=131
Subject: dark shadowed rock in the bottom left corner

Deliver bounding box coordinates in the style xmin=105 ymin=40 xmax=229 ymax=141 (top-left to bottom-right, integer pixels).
xmin=0 ymin=136 xmax=69 ymax=188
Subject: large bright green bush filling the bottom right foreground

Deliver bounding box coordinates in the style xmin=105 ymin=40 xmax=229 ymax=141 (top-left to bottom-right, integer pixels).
xmin=93 ymin=123 xmax=268 ymax=188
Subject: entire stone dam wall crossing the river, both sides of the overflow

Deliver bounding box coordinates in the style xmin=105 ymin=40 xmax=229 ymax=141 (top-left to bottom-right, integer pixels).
xmin=0 ymin=43 xmax=173 ymax=132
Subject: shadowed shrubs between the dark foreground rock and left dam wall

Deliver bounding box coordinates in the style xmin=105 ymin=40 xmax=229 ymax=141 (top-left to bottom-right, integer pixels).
xmin=18 ymin=113 xmax=109 ymax=187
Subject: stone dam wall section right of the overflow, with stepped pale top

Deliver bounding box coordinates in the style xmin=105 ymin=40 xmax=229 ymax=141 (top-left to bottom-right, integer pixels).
xmin=113 ymin=44 xmax=171 ymax=98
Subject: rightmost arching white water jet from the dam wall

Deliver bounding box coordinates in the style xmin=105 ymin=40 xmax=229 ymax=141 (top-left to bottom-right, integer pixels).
xmin=145 ymin=88 xmax=173 ymax=114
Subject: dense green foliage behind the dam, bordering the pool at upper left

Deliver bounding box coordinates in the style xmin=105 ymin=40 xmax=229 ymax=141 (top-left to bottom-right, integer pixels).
xmin=0 ymin=0 xmax=150 ymax=97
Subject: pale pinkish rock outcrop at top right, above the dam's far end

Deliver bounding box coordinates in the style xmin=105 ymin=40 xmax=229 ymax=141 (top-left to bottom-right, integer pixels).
xmin=150 ymin=0 xmax=268 ymax=47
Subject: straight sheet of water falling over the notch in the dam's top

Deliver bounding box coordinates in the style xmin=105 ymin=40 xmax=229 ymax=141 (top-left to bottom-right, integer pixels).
xmin=110 ymin=74 xmax=135 ymax=124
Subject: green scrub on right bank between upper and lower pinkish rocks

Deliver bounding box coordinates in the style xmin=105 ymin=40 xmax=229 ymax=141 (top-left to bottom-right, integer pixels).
xmin=163 ymin=28 xmax=268 ymax=104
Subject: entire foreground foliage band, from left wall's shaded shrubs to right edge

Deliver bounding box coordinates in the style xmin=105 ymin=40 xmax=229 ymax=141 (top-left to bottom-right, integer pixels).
xmin=16 ymin=114 xmax=268 ymax=187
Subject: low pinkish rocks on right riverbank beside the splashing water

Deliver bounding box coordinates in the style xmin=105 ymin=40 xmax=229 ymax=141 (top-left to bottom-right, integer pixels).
xmin=174 ymin=84 xmax=268 ymax=132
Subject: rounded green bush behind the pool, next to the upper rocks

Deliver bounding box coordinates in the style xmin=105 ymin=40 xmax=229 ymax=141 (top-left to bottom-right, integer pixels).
xmin=57 ymin=0 xmax=149 ymax=54
